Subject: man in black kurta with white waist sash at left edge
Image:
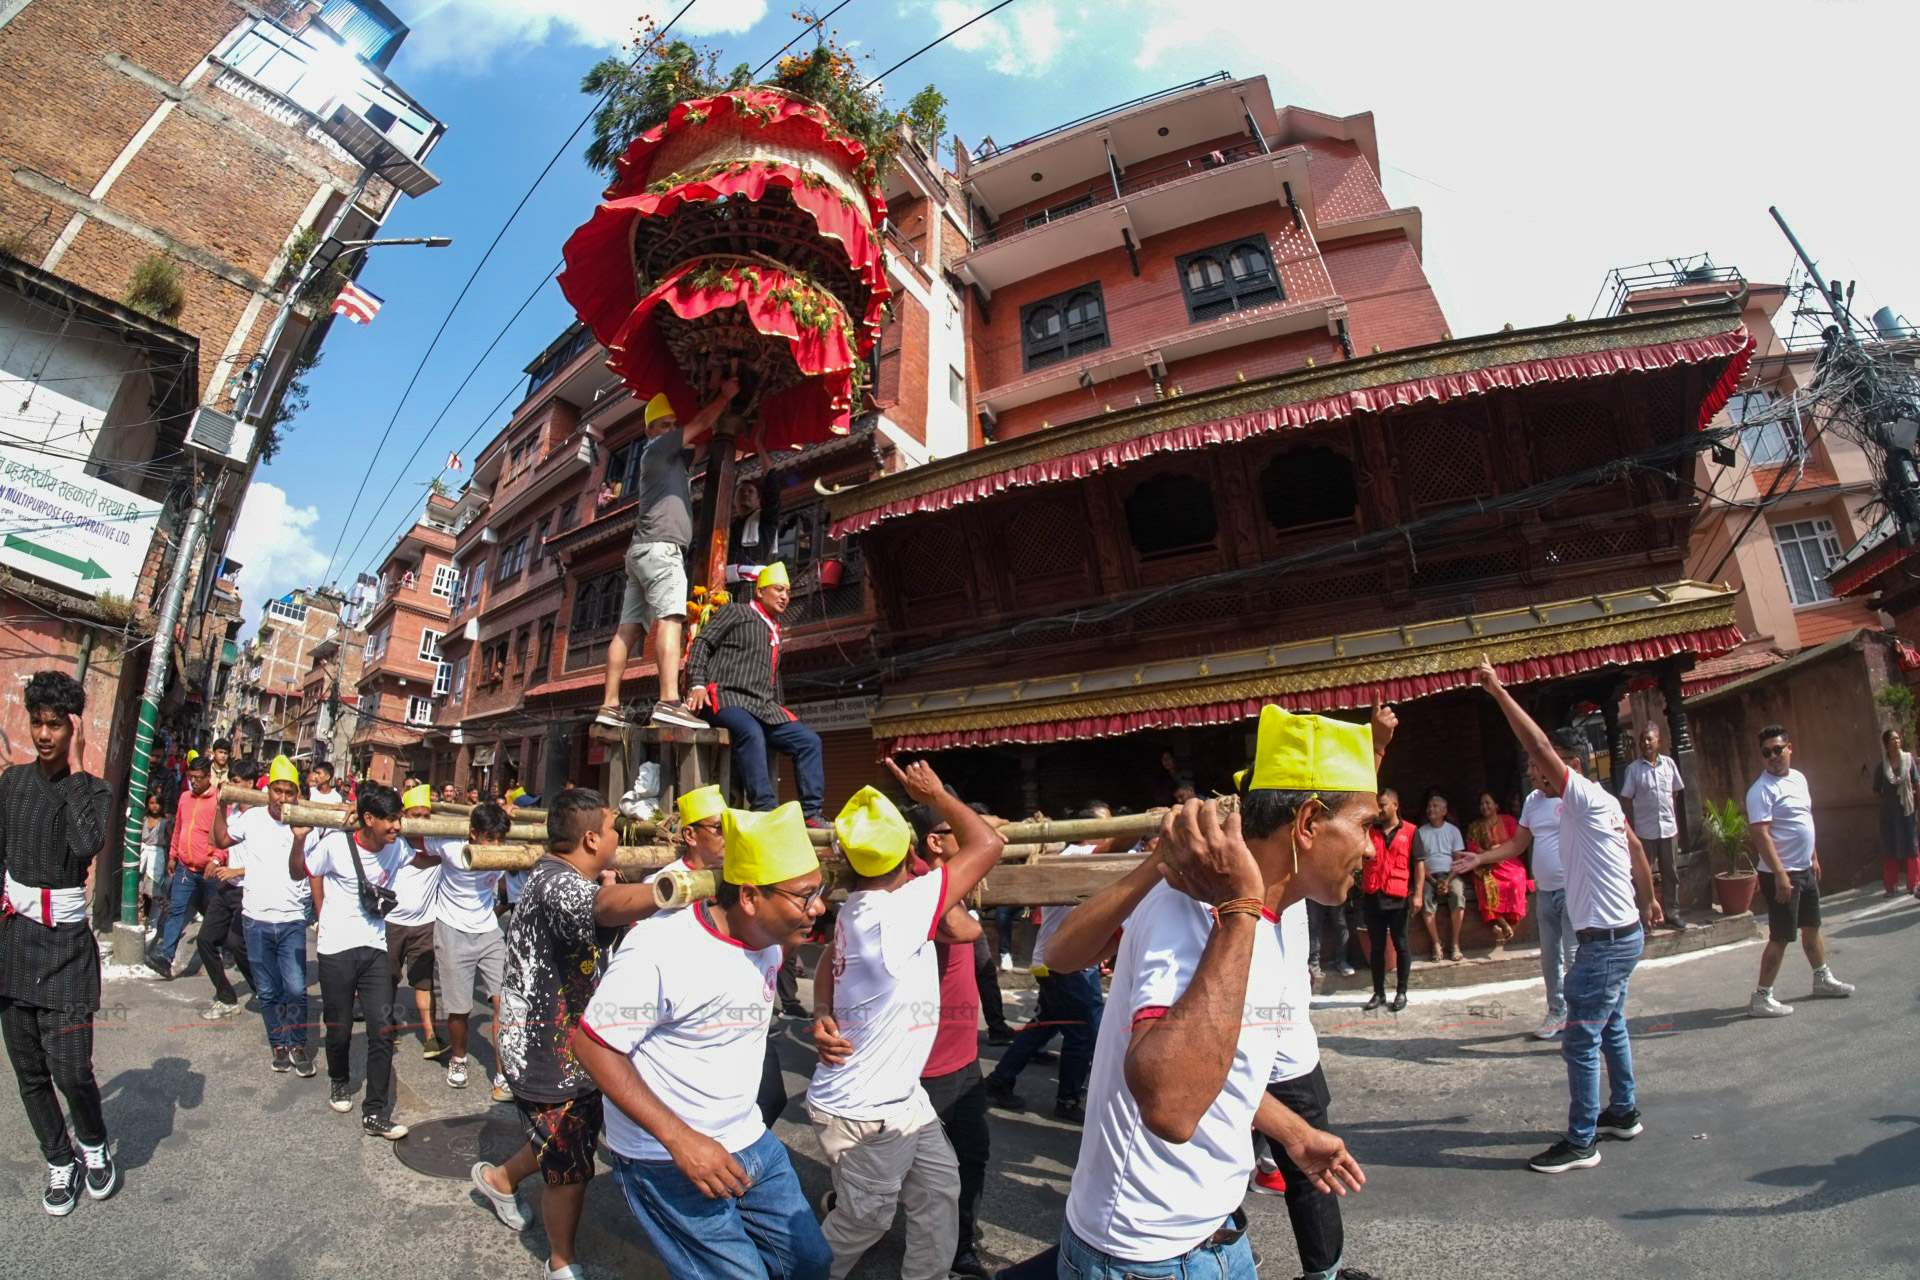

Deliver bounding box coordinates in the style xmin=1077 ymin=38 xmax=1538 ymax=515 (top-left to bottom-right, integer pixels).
xmin=0 ymin=672 xmax=119 ymax=1217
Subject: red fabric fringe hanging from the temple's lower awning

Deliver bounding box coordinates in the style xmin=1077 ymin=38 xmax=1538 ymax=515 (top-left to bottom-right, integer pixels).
xmin=881 ymin=626 xmax=1745 ymax=754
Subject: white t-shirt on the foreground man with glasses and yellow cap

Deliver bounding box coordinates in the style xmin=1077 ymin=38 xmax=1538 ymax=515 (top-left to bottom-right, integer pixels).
xmin=580 ymin=902 xmax=780 ymax=1159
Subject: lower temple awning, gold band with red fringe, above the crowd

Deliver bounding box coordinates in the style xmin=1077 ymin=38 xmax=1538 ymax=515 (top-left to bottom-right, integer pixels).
xmin=874 ymin=581 xmax=1743 ymax=750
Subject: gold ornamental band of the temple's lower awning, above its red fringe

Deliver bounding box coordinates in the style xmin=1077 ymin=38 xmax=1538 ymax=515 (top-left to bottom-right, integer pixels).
xmin=874 ymin=591 xmax=1738 ymax=739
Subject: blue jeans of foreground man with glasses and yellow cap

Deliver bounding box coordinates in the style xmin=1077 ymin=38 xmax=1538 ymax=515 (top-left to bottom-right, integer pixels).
xmin=609 ymin=1130 xmax=833 ymax=1280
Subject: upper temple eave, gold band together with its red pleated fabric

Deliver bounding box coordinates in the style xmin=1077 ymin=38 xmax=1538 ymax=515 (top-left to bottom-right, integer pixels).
xmin=828 ymin=307 xmax=1753 ymax=537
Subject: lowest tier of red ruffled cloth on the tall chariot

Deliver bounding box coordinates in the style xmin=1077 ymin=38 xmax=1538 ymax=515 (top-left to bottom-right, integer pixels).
xmin=607 ymin=263 xmax=856 ymax=451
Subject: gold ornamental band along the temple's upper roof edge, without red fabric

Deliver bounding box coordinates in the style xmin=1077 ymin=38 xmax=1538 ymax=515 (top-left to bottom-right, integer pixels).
xmin=828 ymin=301 xmax=1740 ymax=522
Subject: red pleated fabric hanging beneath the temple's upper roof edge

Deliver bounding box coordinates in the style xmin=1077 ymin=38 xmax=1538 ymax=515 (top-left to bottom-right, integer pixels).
xmin=833 ymin=326 xmax=1753 ymax=537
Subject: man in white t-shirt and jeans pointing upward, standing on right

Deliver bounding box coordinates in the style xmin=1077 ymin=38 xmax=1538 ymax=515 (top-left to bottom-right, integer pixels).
xmin=1453 ymin=658 xmax=1661 ymax=1173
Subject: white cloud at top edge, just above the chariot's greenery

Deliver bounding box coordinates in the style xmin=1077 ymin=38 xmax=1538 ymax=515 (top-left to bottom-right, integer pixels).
xmin=405 ymin=0 xmax=766 ymax=71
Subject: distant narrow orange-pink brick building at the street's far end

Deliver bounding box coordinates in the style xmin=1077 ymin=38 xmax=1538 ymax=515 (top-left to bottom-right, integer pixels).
xmin=351 ymin=493 xmax=457 ymax=787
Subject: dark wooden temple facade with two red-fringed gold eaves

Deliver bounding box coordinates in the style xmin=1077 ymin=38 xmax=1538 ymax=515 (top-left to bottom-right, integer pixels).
xmin=829 ymin=299 xmax=1753 ymax=829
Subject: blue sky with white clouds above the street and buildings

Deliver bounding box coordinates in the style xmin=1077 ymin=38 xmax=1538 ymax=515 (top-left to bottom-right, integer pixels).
xmin=230 ymin=0 xmax=1920 ymax=620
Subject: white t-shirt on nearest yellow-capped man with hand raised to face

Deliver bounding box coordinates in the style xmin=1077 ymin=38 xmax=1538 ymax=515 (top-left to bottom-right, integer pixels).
xmin=1068 ymin=885 xmax=1282 ymax=1263
